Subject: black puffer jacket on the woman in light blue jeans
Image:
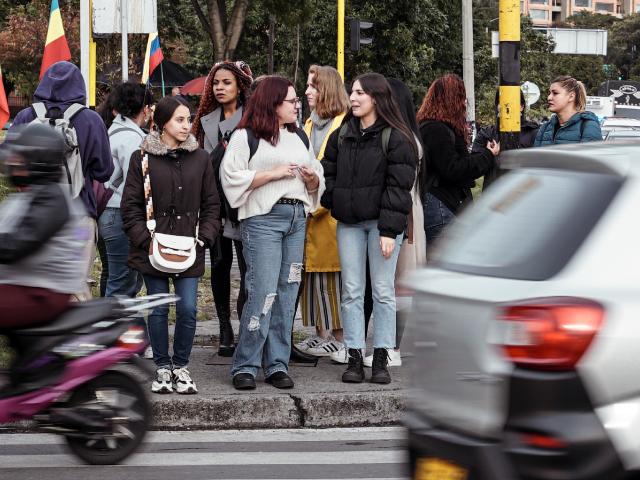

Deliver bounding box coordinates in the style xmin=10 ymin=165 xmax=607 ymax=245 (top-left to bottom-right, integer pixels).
xmin=320 ymin=117 xmax=417 ymax=238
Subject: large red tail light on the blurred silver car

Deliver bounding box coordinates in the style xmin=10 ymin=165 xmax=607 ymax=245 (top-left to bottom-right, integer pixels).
xmin=499 ymin=298 xmax=604 ymax=370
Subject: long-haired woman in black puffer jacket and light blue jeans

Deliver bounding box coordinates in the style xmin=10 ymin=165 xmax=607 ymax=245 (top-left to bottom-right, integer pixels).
xmin=321 ymin=73 xmax=418 ymax=383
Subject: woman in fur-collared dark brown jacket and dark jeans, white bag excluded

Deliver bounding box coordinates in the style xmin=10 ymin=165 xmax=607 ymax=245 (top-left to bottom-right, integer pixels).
xmin=120 ymin=97 xmax=220 ymax=394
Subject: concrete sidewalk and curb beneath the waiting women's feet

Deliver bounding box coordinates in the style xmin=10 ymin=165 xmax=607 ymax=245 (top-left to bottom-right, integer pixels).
xmin=148 ymin=321 xmax=413 ymax=429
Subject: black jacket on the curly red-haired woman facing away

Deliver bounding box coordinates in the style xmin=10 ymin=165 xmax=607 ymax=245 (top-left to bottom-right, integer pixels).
xmin=420 ymin=120 xmax=496 ymax=213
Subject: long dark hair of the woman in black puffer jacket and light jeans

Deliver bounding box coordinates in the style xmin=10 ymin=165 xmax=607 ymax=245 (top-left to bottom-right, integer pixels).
xmin=349 ymin=73 xmax=418 ymax=155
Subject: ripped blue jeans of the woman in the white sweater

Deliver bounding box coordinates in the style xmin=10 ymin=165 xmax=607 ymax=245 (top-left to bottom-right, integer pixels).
xmin=231 ymin=204 xmax=306 ymax=378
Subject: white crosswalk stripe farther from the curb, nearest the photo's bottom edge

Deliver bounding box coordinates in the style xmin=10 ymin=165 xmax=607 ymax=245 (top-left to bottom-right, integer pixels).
xmin=0 ymin=450 xmax=407 ymax=471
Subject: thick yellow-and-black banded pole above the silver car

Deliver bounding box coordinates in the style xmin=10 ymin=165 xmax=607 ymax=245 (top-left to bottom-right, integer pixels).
xmin=499 ymin=0 xmax=520 ymax=149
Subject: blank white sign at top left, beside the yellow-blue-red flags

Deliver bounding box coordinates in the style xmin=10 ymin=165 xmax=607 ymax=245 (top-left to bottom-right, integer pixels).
xmin=93 ymin=0 xmax=158 ymax=35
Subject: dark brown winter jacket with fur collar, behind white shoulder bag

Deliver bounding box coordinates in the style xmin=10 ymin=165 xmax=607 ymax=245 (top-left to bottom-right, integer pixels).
xmin=120 ymin=133 xmax=220 ymax=278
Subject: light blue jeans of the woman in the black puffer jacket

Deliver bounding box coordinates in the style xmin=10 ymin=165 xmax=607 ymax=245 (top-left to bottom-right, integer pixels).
xmin=338 ymin=220 xmax=402 ymax=349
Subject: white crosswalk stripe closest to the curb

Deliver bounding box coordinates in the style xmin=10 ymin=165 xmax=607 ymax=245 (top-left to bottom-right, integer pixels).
xmin=0 ymin=427 xmax=407 ymax=446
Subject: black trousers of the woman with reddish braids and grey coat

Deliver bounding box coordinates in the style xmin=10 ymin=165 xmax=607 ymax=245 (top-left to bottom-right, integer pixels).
xmin=209 ymin=234 xmax=247 ymax=319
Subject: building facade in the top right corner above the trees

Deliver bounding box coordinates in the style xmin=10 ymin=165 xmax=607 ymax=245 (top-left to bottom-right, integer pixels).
xmin=520 ymin=0 xmax=640 ymax=27
